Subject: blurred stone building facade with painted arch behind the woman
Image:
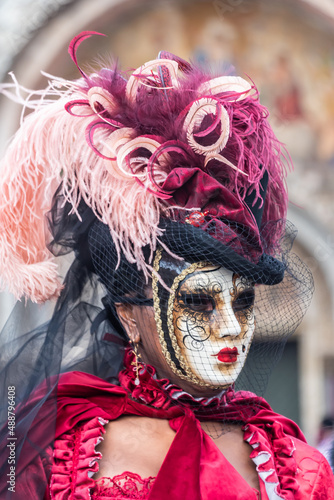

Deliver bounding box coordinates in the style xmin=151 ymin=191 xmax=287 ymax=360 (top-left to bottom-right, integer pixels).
xmin=0 ymin=0 xmax=334 ymax=443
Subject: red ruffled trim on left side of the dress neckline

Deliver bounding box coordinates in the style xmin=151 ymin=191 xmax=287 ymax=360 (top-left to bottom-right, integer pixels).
xmin=50 ymin=417 xmax=108 ymax=500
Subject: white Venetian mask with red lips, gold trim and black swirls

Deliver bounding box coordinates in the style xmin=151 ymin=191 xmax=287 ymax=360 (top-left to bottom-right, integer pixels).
xmin=155 ymin=252 xmax=255 ymax=388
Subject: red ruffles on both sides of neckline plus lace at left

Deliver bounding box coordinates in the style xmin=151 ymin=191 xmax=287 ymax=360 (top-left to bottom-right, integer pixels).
xmin=50 ymin=417 xmax=299 ymax=500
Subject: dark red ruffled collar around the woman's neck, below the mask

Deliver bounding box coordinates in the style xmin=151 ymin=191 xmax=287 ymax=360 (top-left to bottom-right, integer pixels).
xmin=118 ymin=348 xmax=241 ymax=418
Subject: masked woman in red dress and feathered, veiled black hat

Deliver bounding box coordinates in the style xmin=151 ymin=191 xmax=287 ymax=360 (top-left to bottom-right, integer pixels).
xmin=0 ymin=32 xmax=334 ymax=500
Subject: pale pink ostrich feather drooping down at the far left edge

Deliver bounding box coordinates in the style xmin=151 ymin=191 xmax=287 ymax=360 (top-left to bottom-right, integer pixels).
xmin=0 ymin=93 xmax=69 ymax=302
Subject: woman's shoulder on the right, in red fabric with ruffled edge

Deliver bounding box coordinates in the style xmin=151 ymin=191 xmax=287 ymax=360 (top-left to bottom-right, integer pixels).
xmin=244 ymin=406 xmax=334 ymax=500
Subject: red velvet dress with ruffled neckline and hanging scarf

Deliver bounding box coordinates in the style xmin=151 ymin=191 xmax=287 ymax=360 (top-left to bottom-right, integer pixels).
xmin=45 ymin=360 xmax=334 ymax=500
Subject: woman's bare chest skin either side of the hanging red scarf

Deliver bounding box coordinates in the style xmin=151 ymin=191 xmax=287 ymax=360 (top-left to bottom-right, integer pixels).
xmin=95 ymin=417 xmax=259 ymax=489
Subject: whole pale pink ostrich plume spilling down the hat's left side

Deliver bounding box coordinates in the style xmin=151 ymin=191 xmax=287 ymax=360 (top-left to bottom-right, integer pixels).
xmin=0 ymin=73 xmax=161 ymax=302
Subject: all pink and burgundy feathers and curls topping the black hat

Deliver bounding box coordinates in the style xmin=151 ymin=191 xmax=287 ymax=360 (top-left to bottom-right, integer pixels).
xmin=0 ymin=32 xmax=287 ymax=302
